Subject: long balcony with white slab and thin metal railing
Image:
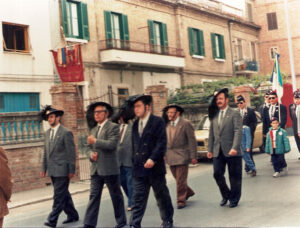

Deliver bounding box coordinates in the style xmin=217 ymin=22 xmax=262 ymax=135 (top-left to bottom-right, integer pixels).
xmin=99 ymin=39 xmax=185 ymax=69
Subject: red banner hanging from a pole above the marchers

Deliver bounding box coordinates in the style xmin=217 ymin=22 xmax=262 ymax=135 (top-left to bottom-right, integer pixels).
xmin=51 ymin=44 xmax=84 ymax=82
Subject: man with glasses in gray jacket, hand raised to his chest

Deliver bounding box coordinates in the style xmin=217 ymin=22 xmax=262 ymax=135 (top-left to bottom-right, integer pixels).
xmin=84 ymin=102 xmax=126 ymax=228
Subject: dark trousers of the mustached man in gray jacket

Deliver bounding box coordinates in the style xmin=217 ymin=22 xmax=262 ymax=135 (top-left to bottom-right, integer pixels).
xmin=213 ymin=149 xmax=242 ymax=203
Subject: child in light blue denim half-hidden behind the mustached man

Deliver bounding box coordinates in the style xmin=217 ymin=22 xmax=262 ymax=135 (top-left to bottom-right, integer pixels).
xmin=241 ymin=125 xmax=256 ymax=177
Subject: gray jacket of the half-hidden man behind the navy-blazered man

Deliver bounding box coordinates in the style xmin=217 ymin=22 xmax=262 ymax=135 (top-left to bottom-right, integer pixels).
xmin=117 ymin=123 xmax=133 ymax=167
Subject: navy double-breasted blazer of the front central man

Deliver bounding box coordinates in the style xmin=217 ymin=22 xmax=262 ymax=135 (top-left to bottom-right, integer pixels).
xmin=132 ymin=114 xmax=167 ymax=177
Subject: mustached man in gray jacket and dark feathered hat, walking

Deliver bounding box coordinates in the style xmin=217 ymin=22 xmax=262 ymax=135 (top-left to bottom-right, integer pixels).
xmin=207 ymin=88 xmax=242 ymax=208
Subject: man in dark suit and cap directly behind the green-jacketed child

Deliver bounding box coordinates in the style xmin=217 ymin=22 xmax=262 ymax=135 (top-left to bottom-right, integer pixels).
xmin=262 ymin=91 xmax=287 ymax=137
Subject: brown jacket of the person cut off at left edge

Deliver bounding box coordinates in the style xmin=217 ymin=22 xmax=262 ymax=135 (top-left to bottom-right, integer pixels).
xmin=0 ymin=147 xmax=12 ymax=218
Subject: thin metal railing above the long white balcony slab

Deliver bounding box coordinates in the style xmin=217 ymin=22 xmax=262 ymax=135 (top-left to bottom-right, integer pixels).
xmin=99 ymin=39 xmax=184 ymax=57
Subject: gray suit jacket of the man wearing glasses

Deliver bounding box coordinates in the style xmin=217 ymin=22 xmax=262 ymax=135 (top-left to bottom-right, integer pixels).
xmin=86 ymin=120 xmax=120 ymax=176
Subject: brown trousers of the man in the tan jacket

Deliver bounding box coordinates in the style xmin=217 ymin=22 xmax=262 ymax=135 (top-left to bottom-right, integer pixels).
xmin=170 ymin=165 xmax=195 ymax=205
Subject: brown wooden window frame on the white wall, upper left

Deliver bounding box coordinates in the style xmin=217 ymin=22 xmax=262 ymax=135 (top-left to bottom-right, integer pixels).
xmin=2 ymin=21 xmax=30 ymax=53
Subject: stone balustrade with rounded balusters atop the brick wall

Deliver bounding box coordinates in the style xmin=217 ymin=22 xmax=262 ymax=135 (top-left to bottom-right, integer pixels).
xmin=0 ymin=112 xmax=44 ymax=145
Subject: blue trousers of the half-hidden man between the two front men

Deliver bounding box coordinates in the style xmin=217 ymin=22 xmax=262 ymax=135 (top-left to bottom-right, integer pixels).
xmin=120 ymin=166 xmax=133 ymax=207
